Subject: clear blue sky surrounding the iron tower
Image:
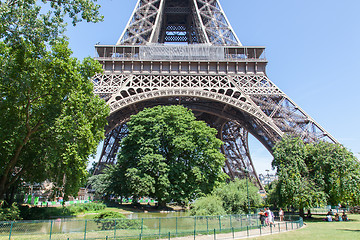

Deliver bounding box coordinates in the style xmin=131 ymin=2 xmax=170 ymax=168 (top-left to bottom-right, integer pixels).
xmin=67 ymin=0 xmax=360 ymax=173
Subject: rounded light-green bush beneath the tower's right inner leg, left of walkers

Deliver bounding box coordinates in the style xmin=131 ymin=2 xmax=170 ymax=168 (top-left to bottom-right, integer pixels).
xmin=213 ymin=179 xmax=262 ymax=214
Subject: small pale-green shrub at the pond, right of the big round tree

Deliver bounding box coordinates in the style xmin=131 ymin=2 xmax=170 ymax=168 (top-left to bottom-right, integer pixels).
xmin=190 ymin=195 xmax=226 ymax=216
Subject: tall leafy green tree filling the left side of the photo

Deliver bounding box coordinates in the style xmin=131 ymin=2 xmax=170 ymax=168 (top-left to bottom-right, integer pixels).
xmin=0 ymin=0 xmax=109 ymax=200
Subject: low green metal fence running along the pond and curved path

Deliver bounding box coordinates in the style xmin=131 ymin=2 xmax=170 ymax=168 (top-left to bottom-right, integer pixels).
xmin=0 ymin=215 xmax=303 ymax=240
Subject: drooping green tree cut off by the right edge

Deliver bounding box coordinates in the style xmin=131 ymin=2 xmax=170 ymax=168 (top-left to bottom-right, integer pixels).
xmin=306 ymin=142 xmax=360 ymax=206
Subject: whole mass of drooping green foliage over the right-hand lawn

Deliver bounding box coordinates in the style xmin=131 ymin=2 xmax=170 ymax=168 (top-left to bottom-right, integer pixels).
xmin=269 ymin=136 xmax=360 ymax=210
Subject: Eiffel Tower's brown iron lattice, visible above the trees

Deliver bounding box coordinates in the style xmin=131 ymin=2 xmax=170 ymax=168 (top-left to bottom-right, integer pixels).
xmin=93 ymin=0 xmax=336 ymax=188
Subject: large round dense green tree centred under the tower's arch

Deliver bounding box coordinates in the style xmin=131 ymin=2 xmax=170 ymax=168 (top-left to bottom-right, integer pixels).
xmin=117 ymin=106 xmax=225 ymax=206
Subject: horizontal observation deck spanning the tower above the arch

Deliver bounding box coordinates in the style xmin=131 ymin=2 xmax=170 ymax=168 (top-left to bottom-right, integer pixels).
xmin=95 ymin=44 xmax=267 ymax=75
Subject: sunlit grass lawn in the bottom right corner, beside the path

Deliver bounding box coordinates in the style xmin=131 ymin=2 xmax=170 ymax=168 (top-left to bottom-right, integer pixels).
xmin=253 ymin=214 xmax=360 ymax=240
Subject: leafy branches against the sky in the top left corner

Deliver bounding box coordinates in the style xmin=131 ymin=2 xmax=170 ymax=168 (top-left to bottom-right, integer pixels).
xmin=0 ymin=0 xmax=103 ymax=43
